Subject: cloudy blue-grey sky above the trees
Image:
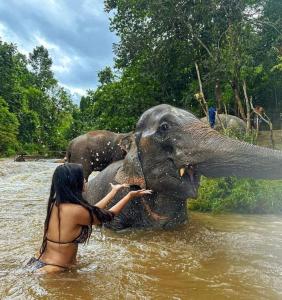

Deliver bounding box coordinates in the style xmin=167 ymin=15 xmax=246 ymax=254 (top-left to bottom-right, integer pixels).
xmin=0 ymin=0 xmax=117 ymax=94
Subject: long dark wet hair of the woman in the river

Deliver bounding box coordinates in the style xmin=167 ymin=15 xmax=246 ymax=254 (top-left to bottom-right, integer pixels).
xmin=40 ymin=163 xmax=114 ymax=254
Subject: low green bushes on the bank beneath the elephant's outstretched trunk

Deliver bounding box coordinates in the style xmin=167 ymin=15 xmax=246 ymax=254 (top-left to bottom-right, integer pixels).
xmin=189 ymin=177 xmax=282 ymax=213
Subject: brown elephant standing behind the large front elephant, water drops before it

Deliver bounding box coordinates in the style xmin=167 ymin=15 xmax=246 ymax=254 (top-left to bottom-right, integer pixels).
xmin=65 ymin=130 xmax=132 ymax=181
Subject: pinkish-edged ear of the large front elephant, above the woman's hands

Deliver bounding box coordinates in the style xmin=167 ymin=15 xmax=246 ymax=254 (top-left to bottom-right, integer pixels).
xmin=115 ymin=139 xmax=146 ymax=189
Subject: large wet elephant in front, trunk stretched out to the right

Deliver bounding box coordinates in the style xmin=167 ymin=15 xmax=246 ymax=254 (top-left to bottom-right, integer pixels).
xmin=85 ymin=104 xmax=282 ymax=230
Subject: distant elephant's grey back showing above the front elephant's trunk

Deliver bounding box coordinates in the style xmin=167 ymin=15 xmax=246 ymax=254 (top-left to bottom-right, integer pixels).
xmin=200 ymin=114 xmax=247 ymax=134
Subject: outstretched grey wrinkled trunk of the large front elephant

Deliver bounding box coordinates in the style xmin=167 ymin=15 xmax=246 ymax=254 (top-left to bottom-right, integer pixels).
xmin=184 ymin=120 xmax=282 ymax=179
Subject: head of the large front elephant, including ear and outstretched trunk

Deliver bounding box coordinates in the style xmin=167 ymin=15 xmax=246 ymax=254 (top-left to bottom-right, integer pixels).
xmin=115 ymin=104 xmax=282 ymax=221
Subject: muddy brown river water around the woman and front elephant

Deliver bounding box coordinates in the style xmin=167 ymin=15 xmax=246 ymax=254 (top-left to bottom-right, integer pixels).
xmin=0 ymin=160 xmax=282 ymax=299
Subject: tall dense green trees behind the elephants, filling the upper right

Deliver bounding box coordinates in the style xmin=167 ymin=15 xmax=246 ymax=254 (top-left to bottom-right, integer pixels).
xmin=71 ymin=0 xmax=282 ymax=131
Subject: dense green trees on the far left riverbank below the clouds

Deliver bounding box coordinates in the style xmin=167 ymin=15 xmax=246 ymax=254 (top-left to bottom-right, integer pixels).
xmin=0 ymin=40 xmax=75 ymax=155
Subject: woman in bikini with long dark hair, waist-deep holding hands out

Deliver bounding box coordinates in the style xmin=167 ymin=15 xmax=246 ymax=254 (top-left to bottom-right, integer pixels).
xmin=28 ymin=163 xmax=151 ymax=273
